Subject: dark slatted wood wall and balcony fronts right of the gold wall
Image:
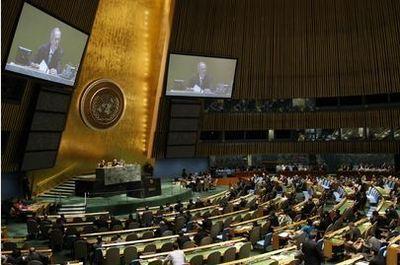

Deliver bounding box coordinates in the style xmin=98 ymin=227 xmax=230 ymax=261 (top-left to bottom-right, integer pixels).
xmin=153 ymin=0 xmax=400 ymax=158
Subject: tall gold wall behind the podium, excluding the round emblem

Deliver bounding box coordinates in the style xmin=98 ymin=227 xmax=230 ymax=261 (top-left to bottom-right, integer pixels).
xmin=28 ymin=0 xmax=173 ymax=194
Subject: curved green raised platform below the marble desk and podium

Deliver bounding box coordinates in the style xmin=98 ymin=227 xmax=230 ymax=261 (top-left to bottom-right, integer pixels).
xmin=38 ymin=182 xmax=227 ymax=215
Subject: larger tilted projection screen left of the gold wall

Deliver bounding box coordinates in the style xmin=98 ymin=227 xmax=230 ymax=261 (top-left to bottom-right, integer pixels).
xmin=5 ymin=3 xmax=88 ymax=86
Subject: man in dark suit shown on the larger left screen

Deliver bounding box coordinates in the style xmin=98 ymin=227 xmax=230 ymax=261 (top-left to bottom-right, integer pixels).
xmin=31 ymin=28 xmax=64 ymax=75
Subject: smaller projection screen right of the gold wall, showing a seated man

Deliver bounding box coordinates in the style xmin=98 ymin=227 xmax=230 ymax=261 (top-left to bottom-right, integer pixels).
xmin=165 ymin=54 xmax=237 ymax=98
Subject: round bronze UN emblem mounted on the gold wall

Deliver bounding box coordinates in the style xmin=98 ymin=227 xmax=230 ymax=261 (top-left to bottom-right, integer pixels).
xmin=80 ymin=79 xmax=125 ymax=130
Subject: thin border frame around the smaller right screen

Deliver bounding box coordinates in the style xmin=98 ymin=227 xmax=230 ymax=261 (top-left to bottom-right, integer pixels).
xmin=163 ymin=52 xmax=239 ymax=99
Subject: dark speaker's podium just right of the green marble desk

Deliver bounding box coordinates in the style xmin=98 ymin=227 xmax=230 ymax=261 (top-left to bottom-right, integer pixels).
xmin=126 ymin=176 xmax=161 ymax=198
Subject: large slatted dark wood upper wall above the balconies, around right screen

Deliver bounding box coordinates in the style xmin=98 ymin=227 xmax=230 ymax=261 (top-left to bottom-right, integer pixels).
xmin=170 ymin=0 xmax=400 ymax=98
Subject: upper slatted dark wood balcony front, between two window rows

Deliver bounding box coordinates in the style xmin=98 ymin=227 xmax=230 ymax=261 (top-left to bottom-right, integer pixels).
xmin=201 ymin=108 xmax=400 ymax=131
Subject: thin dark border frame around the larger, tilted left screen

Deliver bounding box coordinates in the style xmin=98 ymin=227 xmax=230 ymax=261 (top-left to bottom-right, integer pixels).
xmin=1 ymin=0 xmax=91 ymax=88
